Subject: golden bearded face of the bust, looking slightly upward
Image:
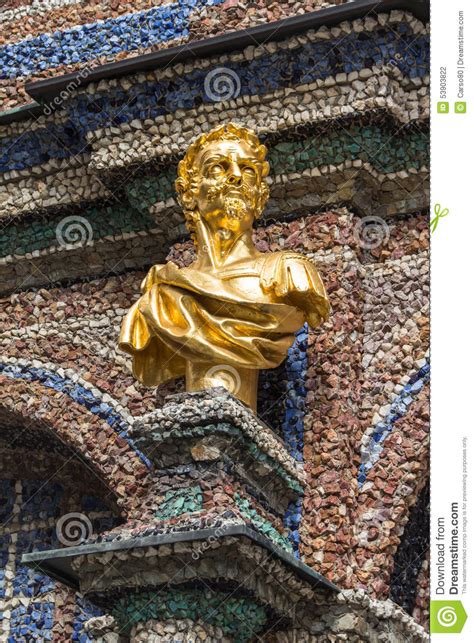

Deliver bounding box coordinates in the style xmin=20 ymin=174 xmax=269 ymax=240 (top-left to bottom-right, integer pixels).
xmin=196 ymin=141 xmax=262 ymax=235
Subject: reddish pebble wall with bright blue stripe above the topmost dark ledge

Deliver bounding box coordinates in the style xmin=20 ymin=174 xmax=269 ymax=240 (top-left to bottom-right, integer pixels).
xmin=0 ymin=0 xmax=345 ymax=110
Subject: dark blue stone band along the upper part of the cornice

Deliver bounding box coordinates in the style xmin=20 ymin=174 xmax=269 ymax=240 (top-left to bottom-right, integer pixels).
xmin=0 ymin=25 xmax=429 ymax=172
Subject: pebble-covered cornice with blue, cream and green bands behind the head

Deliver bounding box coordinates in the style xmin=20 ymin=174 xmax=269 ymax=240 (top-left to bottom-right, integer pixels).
xmin=0 ymin=8 xmax=429 ymax=300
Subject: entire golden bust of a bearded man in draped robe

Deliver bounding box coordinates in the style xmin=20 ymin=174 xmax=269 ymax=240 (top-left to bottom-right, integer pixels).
xmin=119 ymin=123 xmax=329 ymax=409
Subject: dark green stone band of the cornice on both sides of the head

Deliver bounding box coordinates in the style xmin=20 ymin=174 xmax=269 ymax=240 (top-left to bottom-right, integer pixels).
xmin=0 ymin=125 xmax=429 ymax=257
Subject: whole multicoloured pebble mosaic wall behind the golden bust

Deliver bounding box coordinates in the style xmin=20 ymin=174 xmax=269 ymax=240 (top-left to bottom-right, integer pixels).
xmin=0 ymin=0 xmax=429 ymax=641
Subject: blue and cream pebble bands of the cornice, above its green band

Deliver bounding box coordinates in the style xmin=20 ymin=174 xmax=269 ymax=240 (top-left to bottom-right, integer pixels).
xmin=1 ymin=11 xmax=429 ymax=224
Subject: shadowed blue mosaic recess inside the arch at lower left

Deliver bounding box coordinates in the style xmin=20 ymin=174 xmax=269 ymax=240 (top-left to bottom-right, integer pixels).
xmin=0 ymin=438 xmax=118 ymax=642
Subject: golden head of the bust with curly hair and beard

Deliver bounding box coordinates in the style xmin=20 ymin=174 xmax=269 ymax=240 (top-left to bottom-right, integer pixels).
xmin=176 ymin=123 xmax=269 ymax=242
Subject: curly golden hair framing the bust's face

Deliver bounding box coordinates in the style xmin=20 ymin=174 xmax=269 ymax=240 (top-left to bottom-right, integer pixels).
xmin=175 ymin=123 xmax=270 ymax=239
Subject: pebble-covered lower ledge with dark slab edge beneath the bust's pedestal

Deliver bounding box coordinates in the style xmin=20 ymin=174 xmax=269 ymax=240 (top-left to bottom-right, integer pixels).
xmin=23 ymin=525 xmax=428 ymax=643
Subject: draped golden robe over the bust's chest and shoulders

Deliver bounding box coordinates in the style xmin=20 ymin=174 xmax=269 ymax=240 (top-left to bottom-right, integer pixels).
xmin=119 ymin=252 xmax=329 ymax=386
